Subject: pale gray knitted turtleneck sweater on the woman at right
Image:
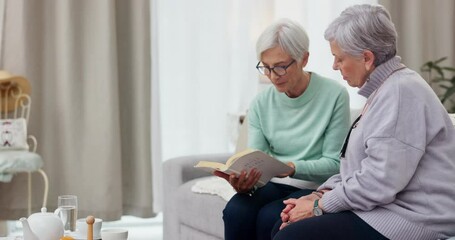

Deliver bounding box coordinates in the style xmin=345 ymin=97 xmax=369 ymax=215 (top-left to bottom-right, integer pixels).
xmin=319 ymin=57 xmax=455 ymax=240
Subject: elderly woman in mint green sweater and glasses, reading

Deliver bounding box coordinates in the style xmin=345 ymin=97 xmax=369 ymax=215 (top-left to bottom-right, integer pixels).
xmin=215 ymin=19 xmax=350 ymax=240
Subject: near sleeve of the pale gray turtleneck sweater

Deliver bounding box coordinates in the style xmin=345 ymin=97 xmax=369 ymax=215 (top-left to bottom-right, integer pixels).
xmin=321 ymin=78 xmax=428 ymax=212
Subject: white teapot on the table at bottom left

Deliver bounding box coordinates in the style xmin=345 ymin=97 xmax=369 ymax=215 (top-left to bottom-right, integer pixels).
xmin=19 ymin=207 xmax=64 ymax=240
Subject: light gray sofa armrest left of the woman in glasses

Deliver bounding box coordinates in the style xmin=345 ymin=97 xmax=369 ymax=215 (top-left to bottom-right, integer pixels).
xmin=163 ymin=153 xmax=232 ymax=240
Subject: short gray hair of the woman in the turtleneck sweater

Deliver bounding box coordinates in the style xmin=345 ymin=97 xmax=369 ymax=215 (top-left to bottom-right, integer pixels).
xmin=324 ymin=4 xmax=398 ymax=66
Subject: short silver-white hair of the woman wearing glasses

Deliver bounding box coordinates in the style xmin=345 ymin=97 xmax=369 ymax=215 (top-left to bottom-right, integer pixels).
xmin=256 ymin=18 xmax=310 ymax=61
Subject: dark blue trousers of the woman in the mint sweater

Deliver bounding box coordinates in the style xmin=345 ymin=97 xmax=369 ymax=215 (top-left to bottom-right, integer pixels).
xmin=223 ymin=182 xmax=313 ymax=240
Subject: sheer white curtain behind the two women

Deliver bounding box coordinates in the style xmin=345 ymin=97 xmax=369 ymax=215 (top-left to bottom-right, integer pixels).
xmin=155 ymin=0 xmax=376 ymax=163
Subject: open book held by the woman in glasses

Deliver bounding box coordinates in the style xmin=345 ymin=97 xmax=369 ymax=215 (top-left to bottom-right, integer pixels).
xmin=194 ymin=149 xmax=292 ymax=187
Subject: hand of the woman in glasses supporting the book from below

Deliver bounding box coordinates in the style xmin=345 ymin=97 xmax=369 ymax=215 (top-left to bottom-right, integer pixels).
xmin=213 ymin=168 xmax=262 ymax=193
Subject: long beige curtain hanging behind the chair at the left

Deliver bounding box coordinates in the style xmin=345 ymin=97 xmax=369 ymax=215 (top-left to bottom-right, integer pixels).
xmin=0 ymin=0 xmax=154 ymax=220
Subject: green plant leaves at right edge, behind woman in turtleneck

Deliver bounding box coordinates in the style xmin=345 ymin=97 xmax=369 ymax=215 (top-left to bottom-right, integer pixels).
xmin=420 ymin=57 xmax=455 ymax=113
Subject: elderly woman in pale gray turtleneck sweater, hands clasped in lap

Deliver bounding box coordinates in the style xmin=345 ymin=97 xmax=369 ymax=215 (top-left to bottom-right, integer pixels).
xmin=272 ymin=5 xmax=455 ymax=240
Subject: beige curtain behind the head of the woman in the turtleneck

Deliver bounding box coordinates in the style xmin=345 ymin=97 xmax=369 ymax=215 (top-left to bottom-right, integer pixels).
xmin=379 ymin=0 xmax=455 ymax=75
